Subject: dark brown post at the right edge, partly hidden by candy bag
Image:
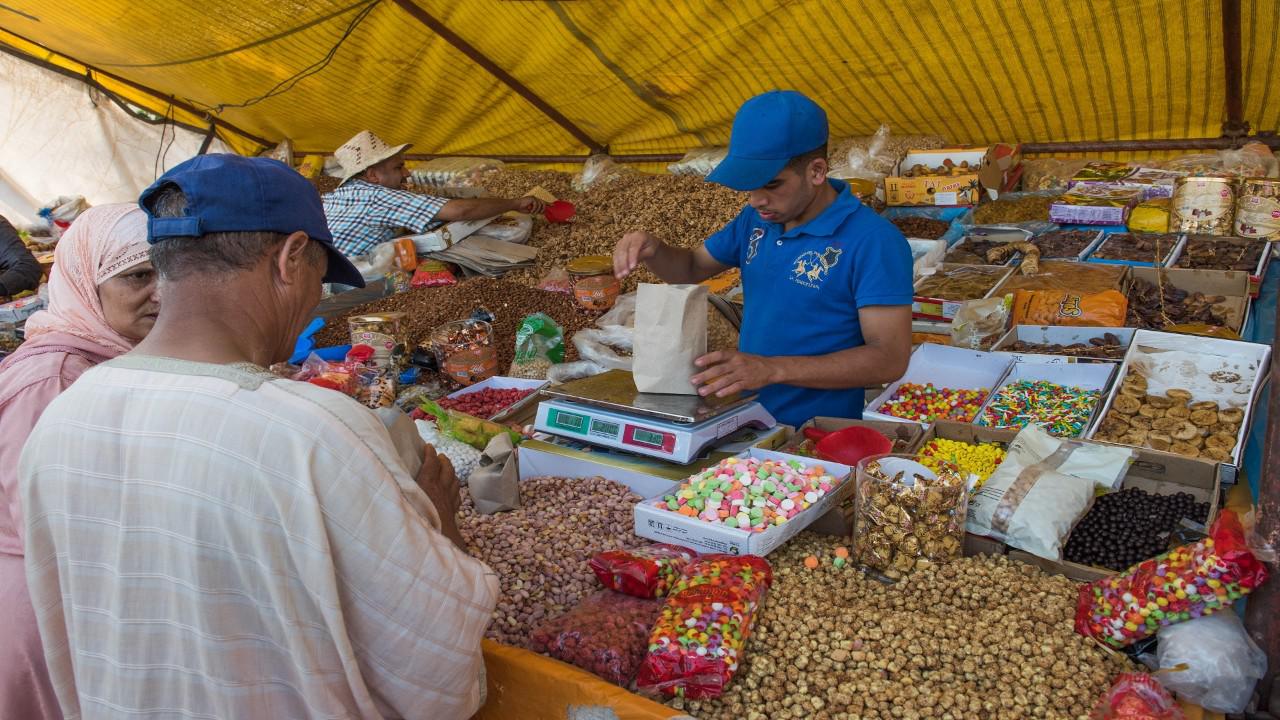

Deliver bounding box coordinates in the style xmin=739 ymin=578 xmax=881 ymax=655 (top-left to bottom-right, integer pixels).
xmin=1244 ymin=304 xmax=1280 ymax=714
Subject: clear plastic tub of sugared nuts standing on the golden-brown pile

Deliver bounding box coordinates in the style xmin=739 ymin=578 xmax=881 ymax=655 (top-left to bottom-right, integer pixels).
xmin=854 ymin=455 xmax=969 ymax=580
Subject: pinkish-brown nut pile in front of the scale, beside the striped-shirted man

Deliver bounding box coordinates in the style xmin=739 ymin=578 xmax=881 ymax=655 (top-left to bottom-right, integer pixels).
xmin=458 ymin=478 xmax=643 ymax=647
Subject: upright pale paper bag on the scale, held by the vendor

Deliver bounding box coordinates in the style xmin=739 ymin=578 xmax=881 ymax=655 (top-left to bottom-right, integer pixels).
xmin=631 ymin=284 xmax=707 ymax=395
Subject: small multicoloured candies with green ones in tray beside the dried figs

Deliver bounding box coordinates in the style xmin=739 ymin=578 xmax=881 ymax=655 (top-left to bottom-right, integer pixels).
xmin=978 ymin=380 xmax=1102 ymax=437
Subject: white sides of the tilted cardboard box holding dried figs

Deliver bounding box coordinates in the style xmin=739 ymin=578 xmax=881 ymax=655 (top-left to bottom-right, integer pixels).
xmin=1088 ymin=331 xmax=1271 ymax=484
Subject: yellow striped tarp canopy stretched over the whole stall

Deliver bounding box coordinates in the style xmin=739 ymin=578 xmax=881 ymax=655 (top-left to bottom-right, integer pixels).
xmin=0 ymin=0 xmax=1280 ymax=155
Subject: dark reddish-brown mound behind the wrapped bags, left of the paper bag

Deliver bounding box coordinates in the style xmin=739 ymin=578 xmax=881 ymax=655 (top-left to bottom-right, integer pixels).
xmin=316 ymin=278 xmax=594 ymax=368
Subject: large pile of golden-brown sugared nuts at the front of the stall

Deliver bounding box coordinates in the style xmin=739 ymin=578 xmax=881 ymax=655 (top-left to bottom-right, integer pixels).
xmin=669 ymin=533 xmax=1132 ymax=720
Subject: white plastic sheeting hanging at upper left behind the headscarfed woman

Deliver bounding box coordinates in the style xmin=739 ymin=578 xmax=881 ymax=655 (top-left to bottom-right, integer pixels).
xmin=0 ymin=54 xmax=225 ymax=225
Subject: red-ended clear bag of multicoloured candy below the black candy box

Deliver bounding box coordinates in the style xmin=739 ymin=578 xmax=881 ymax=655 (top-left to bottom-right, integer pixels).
xmin=1075 ymin=510 xmax=1267 ymax=648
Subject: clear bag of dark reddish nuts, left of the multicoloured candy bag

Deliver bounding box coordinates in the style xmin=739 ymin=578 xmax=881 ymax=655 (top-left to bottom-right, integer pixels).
xmin=529 ymin=591 xmax=662 ymax=688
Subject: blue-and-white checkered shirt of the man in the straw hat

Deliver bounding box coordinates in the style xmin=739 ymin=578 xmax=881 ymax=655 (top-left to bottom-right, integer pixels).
xmin=323 ymin=179 xmax=448 ymax=256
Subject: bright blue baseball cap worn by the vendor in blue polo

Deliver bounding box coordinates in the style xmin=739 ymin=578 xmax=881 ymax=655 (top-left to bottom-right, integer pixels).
xmin=707 ymin=90 xmax=827 ymax=191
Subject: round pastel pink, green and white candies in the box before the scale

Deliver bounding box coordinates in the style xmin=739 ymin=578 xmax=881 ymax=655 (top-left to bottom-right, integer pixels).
xmin=655 ymin=457 xmax=840 ymax=533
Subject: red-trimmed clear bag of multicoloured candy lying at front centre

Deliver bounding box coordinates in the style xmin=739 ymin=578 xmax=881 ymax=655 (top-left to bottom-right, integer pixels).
xmin=636 ymin=555 xmax=773 ymax=700
